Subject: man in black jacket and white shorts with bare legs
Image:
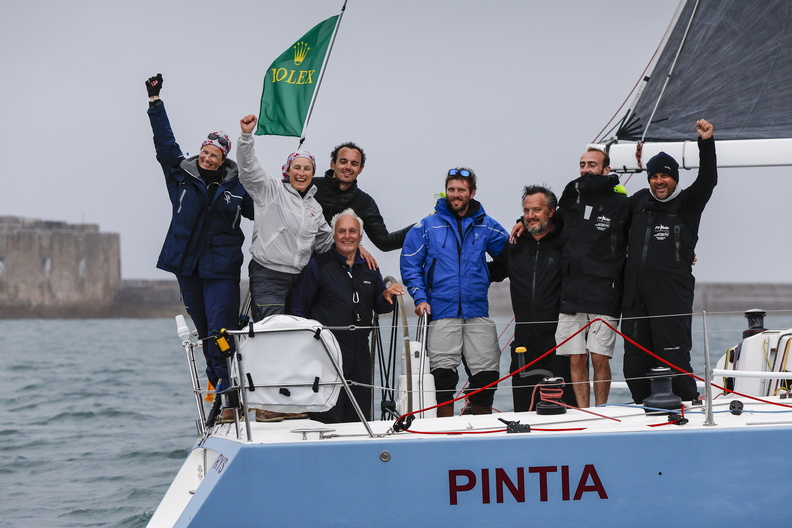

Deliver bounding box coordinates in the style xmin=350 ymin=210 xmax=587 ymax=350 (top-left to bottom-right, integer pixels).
xmin=556 ymin=147 xmax=630 ymax=407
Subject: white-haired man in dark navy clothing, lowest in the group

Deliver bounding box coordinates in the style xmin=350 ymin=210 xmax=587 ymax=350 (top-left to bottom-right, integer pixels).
xmin=291 ymin=209 xmax=404 ymax=423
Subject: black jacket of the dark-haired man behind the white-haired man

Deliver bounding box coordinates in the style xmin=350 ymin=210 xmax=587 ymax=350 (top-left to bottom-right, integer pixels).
xmin=313 ymin=170 xmax=412 ymax=251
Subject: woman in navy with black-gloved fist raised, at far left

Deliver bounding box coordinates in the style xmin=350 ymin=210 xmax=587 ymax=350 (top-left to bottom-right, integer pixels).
xmin=146 ymin=73 xmax=253 ymax=421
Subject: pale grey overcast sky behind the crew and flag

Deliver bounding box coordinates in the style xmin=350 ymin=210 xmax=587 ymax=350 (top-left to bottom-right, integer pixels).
xmin=0 ymin=0 xmax=792 ymax=282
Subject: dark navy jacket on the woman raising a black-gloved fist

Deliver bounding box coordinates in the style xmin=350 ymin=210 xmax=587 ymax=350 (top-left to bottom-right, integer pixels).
xmin=148 ymin=101 xmax=253 ymax=280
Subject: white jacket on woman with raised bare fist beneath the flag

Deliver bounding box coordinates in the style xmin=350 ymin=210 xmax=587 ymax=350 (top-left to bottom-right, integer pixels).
xmin=237 ymin=134 xmax=333 ymax=274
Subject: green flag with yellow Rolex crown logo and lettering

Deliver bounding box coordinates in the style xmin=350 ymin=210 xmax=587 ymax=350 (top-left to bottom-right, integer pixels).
xmin=256 ymin=15 xmax=339 ymax=137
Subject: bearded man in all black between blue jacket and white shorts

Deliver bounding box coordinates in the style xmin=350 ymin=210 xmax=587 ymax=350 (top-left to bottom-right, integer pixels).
xmin=490 ymin=185 xmax=576 ymax=412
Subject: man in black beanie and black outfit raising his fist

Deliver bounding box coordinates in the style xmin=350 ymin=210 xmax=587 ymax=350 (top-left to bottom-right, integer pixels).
xmin=622 ymin=119 xmax=718 ymax=403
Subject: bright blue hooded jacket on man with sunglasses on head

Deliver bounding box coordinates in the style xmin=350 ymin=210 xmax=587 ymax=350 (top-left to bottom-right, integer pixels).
xmin=400 ymin=198 xmax=509 ymax=319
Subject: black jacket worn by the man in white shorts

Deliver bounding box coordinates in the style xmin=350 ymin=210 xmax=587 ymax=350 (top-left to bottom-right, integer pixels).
xmin=558 ymin=175 xmax=630 ymax=317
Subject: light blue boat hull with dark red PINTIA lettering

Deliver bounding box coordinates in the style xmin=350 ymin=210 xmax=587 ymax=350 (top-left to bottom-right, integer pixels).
xmin=152 ymin=418 xmax=792 ymax=527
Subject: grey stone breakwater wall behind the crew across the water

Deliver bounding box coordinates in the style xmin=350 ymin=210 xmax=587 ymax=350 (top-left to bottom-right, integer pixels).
xmin=0 ymin=216 xmax=792 ymax=319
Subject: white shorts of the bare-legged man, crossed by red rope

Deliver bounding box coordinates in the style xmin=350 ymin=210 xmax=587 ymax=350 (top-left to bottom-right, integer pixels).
xmin=556 ymin=313 xmax=619 ymax=357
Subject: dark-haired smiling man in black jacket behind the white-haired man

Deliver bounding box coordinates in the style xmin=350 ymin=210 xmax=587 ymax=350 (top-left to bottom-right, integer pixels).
xmin=314 ymin=142 xmax=412 ymax=254
